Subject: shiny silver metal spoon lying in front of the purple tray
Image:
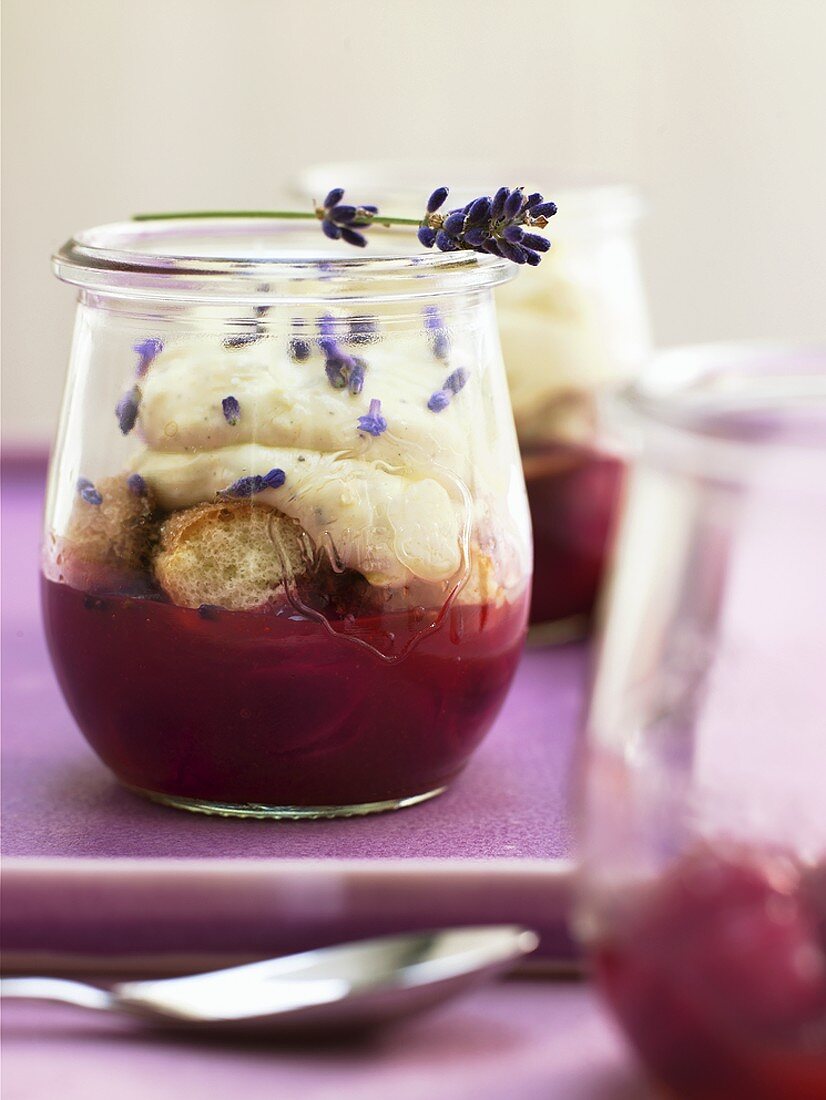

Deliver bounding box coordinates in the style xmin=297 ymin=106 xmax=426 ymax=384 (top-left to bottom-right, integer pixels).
xmin=0 ymin=925 xmax=539 ymax=1033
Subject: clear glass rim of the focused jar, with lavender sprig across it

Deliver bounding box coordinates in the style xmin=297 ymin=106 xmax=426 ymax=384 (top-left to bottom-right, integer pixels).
xmin=52 ymin=217 xmax=516 ymax=303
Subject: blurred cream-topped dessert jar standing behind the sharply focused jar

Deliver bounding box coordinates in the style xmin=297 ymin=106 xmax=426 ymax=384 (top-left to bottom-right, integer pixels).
xmin=296 ymin=162 xmax=651 ymax=640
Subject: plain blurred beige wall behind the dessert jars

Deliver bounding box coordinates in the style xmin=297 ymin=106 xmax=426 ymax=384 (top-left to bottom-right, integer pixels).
xmin=2 ymin=0 xmax=826 ymax=442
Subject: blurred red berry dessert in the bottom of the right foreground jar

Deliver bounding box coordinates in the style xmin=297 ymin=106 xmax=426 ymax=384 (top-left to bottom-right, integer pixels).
xmin=594 ymin=846 xmax=826 ymax=1100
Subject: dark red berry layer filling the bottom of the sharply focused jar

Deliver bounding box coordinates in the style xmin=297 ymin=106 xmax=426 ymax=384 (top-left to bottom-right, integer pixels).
xmin=43 ymin=578 xmax=528 ymax=807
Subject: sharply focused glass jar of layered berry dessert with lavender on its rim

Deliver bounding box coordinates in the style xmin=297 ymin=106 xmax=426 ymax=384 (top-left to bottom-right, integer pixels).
xmin=43 ymin=219 xmax=530 ymax=817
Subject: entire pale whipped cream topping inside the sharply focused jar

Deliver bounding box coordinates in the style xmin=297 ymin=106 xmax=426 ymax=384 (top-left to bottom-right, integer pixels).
xmin=131 ymin=326 xmax=522 ymax=586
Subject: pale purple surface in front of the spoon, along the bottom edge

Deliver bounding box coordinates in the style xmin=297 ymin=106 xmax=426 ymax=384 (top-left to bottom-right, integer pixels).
xmin=3 ymin=981 xmax=653 ymax=1100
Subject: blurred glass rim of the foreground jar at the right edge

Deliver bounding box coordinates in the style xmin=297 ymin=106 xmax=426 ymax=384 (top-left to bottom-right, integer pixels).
xmin=608 ymin=341 xmax=826 ymax=477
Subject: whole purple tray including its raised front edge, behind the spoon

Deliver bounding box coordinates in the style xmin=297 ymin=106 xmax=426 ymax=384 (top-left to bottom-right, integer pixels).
xmin=2 ymin=461 xmax=585 ymax=970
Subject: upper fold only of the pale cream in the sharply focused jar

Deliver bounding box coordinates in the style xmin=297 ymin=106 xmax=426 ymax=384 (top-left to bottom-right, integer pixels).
xmin=140 ymin=334 xmax=473 ymax=473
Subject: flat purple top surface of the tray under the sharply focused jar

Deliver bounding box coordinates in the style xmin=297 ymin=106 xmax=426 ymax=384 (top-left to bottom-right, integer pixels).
xmin=2 ymin=462 xmax=585 ymax=859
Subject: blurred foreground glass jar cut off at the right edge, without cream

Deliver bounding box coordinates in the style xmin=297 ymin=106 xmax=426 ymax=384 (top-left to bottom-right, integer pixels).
xmin=577 ymin=345 xmax=826 ymax=1100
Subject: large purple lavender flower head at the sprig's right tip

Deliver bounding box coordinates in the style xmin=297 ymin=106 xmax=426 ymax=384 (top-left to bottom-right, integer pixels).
xmin=418 ymin=187 xmax=557 ymax=267
